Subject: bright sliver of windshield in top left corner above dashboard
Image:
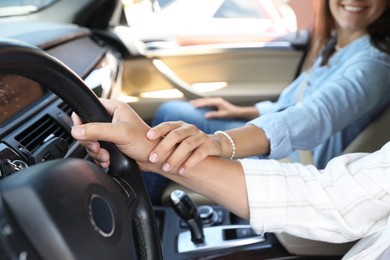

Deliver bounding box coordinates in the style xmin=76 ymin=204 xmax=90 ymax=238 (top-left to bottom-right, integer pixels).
xmin=0 ymin=0 xmax=59 ymax=16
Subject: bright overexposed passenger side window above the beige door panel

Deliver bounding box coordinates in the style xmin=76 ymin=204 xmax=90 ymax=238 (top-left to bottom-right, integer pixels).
xmin=122 ymin=0 xmax=314 ymax=41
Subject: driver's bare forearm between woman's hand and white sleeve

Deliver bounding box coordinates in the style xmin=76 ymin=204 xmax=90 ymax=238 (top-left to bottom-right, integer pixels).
xmin=142 ymin=157 xmax=249 ymax=219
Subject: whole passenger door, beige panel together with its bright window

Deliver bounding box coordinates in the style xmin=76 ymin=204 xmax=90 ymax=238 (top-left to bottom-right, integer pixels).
xmin=116 ymin=0 xmax=311 ymax=119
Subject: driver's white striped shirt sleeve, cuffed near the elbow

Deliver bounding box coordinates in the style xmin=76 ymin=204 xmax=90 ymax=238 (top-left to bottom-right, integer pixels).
xmin=240 ymin=142 xmax=390 ymax=243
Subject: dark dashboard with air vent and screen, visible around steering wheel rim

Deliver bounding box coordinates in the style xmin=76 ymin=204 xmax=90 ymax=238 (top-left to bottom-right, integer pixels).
xmin=0 ymin=23 xmax=122 ymax=174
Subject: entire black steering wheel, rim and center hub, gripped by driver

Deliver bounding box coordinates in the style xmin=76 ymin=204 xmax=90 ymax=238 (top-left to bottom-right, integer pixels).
xmin=0 ymin=40 xmax=163 ymax=259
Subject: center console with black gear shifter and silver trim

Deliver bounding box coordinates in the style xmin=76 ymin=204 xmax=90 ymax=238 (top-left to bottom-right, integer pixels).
xmin=155 ymin=192 xmax=290 ymax=260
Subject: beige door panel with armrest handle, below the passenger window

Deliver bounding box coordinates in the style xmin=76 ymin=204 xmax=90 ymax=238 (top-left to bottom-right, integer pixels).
xmin=123 ymin=38 xmax=304 ymax=119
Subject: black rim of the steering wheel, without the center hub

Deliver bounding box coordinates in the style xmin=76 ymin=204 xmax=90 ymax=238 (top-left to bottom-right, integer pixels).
xmin=0 ymin=39 xmax=163 ymax=259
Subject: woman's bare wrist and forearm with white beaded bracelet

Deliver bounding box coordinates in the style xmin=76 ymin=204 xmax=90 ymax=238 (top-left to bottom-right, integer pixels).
xmin=210 ymin=125 xmax=270 ymax=159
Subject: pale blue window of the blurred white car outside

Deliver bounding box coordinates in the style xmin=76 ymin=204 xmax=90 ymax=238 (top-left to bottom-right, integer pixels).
xmin=214 ymin=0 xmax=264 ymax=18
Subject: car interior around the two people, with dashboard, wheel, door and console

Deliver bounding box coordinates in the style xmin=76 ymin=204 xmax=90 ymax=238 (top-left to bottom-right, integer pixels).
xmin=0 ymin=0 xmax=390 ymax=259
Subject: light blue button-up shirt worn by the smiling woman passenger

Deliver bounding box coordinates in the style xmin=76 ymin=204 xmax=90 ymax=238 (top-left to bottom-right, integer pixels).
xmin=248 ymin=35 xmax=390 ymax=168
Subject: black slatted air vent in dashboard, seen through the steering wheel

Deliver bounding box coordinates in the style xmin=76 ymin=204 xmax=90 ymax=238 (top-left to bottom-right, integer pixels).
xmin=15 ymin=115 xmax=74 ymax=153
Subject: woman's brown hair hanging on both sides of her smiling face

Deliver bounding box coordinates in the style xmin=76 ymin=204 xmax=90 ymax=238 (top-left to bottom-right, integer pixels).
xmin=306 ymin=0 xmax=390 ymax=67
